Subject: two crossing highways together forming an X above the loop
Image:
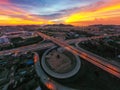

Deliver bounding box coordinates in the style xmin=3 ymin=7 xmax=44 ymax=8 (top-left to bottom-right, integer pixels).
xmin=0 ymin=32 xmax=120 ymax=78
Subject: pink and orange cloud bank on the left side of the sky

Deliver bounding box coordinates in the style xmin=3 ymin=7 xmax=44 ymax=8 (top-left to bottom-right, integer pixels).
xmin=0 ymin=0 xmax=52 ymax=25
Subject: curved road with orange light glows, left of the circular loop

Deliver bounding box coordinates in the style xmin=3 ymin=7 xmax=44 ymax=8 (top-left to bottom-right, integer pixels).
xmin=34 ymin=52 xmax=77 ymax=90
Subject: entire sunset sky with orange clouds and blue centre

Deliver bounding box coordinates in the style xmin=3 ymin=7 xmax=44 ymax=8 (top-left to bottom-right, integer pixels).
xmin=0 ymin=0 xmax=120 ymax=25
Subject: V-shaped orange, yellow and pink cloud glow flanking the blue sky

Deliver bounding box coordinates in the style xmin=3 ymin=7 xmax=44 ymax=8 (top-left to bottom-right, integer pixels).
xmin=0 ymin=0 xmax=120 ymax=25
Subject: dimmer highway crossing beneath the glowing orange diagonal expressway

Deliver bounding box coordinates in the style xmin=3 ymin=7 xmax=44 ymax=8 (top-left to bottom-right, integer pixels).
xmin=0 ymin=32 xmax=120 ymax=56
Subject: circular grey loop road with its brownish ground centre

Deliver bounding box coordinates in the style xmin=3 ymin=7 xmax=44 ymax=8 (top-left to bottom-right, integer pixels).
xmin=41 ymin=47 xmax=81 ymax=79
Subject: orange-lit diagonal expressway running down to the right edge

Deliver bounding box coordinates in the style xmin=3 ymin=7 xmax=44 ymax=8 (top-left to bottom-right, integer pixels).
xmin=37 ymin=32 xmax=120 ymax=78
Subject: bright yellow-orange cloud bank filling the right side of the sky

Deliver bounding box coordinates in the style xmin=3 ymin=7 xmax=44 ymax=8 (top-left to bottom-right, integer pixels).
xmin=65 ymin=0 xmax=120 ymax=25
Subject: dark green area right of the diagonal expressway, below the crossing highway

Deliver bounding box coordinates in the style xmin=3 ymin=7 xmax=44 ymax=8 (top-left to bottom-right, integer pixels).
xmin=79 ymin=40 xmax=120 ymax=61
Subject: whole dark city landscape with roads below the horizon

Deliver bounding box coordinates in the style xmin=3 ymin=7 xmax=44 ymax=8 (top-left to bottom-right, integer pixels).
xmin=0 ymin=24 xmax=120 ymax=90
